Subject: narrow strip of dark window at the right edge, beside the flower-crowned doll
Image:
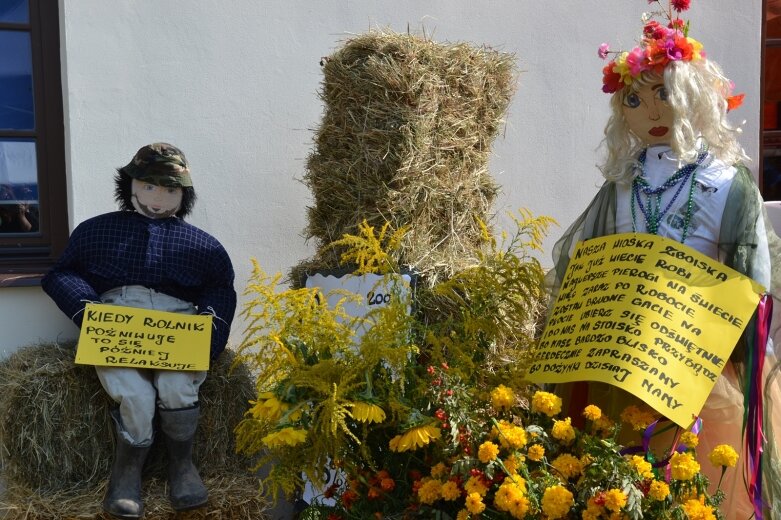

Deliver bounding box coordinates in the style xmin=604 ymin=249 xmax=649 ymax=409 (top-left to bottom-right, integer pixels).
xmin=760 ymin=0 xmax=781 ymax=200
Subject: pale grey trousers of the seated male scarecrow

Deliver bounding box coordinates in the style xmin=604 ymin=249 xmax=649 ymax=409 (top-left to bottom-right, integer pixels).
xmin=95 ymin=285 xmax=206 ymax=447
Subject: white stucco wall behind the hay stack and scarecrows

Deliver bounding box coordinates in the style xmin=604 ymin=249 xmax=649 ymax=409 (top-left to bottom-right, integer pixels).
xmin=0 ymin=0 xmax=762 ymax=355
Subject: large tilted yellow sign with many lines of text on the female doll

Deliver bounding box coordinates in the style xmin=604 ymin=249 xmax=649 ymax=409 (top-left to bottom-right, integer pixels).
xmin=529 ymin=233 xmax=764 ymax=427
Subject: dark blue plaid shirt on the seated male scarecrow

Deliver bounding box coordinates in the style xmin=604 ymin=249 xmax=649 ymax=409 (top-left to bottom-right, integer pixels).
xmin=41 ymin=211 xmax=236 ymax=359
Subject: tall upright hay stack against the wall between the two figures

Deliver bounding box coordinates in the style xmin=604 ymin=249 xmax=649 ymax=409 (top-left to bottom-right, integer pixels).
xmin=294 ymin=31 xmax=515 ymax=285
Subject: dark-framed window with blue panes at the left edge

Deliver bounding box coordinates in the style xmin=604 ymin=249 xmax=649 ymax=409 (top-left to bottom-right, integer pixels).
xmin=0 ymin=0 xmax=68 ymax=285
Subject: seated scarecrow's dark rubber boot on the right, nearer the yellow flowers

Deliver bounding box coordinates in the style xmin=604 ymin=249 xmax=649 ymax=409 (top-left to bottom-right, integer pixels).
xmin=160 ymin=405 xmax=209 ymax=511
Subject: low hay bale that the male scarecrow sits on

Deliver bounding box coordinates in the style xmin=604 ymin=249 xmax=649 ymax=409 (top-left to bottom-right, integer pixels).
xmin=0 ymin=344 xmax=266 ymax=520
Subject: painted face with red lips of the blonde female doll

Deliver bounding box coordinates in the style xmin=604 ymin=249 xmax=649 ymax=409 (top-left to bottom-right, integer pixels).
xmin=621 ymin=82 xmax=673 ymax=145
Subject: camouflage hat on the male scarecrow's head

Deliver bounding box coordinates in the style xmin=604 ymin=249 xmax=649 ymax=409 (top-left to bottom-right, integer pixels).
xmin=122 ymin=143 xmax=193 ymax=188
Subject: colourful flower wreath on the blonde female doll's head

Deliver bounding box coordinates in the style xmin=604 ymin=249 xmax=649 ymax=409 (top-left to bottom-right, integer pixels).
xmin=598 ymin=0 xmax=744 ymax=110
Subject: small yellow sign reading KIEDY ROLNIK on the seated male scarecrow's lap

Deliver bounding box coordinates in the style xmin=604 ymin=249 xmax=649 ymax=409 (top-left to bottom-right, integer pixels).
xmin=76 ymin=303 xmax=212 ymax=370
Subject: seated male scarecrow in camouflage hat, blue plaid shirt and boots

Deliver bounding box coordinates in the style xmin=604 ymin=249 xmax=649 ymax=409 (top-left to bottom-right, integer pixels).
xmin=42 ymin=143 xmax=236 ymax=519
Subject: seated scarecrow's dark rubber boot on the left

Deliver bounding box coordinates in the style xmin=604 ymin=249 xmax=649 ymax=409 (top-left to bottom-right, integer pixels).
xmin=103 ymin=410 xmax=149 ymax=520
